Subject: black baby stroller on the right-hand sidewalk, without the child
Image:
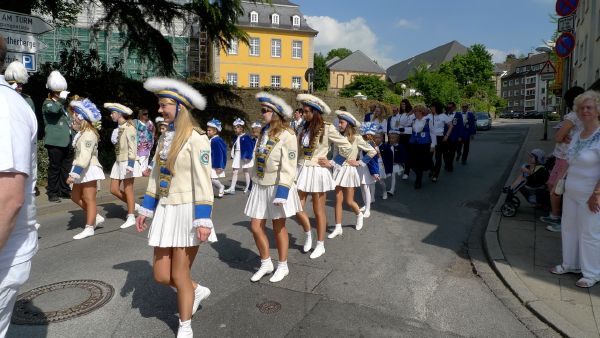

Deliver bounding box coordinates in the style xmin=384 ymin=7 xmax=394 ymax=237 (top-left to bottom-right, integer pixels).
xmin=500 ymin=161 xmax=550 ymax=217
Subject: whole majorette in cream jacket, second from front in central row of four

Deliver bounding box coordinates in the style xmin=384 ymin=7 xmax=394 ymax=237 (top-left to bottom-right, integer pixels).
xmin=244 ymin=92 xmax=302 ymax=283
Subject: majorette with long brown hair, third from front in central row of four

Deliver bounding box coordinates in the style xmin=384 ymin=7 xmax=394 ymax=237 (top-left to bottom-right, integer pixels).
xmin=296 ymin=94 xmax=352 ymax=259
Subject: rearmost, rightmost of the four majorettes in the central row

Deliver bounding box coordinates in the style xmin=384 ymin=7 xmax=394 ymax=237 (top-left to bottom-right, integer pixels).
xmin=327 ymin=110 xmax=377 ymax=238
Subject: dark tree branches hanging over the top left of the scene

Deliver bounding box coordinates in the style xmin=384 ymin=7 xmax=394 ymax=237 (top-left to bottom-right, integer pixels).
xmin=2 ymin=0 xmax=271 ymax=75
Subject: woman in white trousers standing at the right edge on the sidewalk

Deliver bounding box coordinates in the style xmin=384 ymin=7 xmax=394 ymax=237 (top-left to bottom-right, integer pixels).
xmin=550 ymin=91 xmax=600 ymax=288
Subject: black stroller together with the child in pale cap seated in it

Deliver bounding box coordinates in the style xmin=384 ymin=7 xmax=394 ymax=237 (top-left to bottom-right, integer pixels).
xmin=500 ymin=149 xmax=550 ymax=217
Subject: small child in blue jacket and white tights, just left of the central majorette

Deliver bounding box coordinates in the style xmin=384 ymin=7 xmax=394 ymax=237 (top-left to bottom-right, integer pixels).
xmin=225 ymin=118 xmax=255 ymax=195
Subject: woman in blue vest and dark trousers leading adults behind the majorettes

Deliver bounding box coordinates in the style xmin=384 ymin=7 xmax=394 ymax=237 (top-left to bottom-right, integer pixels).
xmin=408 ymin=106 xmax=437 ymax=189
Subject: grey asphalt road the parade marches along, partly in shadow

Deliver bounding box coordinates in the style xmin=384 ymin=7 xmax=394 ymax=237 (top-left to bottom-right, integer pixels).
xmin=9 ymin=124 xmax=531 ymax=337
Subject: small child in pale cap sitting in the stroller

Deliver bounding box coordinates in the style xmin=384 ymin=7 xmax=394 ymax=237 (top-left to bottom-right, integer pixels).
xmin=503 ymin=148 xmax=549 ymax=203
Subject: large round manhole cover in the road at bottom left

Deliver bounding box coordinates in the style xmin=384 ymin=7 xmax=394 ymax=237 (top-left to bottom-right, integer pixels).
xmin=12 ymin=280 xmax=115 ymax=325
